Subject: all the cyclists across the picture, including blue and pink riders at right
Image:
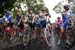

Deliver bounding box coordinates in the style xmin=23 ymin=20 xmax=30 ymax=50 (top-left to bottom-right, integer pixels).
xmin=0 ymin=5 xmax=74 ymax=45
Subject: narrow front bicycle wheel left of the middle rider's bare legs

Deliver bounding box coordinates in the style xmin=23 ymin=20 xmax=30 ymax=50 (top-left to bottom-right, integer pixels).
xmin=22 ymin=24 xmax=31 ymax=46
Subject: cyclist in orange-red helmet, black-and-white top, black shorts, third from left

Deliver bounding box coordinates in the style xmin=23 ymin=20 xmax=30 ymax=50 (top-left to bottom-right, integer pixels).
xmin=27 ymin=8 xmax=36 ymax=40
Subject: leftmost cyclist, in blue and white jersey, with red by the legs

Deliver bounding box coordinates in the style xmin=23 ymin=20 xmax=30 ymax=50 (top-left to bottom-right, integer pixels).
xmin=3 ymin=11 xmax=12 ymax=39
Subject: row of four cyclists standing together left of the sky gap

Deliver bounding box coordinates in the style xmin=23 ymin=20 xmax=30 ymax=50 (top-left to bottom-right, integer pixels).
xmin=0 ymin=8 xmax=52 ymax=44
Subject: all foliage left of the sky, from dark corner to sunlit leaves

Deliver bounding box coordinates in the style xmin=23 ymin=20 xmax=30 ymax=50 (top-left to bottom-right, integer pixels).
xmin=0 ymin=0 xmax=48 ymax=17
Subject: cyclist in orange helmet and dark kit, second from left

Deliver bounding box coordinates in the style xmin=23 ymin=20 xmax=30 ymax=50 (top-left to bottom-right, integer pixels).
xmin=15 ymin=9 xmax=24 ymax=32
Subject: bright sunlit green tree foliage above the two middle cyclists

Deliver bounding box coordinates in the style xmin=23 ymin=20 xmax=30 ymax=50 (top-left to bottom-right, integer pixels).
xmin=26 ymin=0 xmax=44 ymax=14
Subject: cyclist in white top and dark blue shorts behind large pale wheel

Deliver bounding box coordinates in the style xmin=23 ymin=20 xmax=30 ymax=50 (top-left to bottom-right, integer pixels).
xmin=39 ymin=9 xmax=46 ymax=42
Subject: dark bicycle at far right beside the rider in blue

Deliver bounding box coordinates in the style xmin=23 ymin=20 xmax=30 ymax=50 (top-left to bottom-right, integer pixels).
xmin=62 ymin=23 xmax=75 ymax=49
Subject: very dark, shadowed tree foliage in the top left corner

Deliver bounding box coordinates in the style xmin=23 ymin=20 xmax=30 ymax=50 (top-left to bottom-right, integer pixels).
xmin=0 ymin=0 xmax=16 ymax=17
